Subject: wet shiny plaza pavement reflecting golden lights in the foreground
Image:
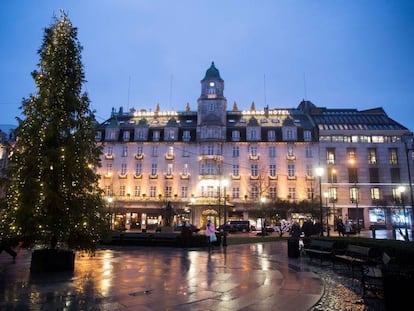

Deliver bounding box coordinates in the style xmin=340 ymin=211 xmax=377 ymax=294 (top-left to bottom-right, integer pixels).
xmin=0 ymin=241 xmax=384 ymax=311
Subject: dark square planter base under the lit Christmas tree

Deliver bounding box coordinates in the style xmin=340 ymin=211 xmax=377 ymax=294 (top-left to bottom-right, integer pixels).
xmin=30 ymin=249 xmax=75 ymax=272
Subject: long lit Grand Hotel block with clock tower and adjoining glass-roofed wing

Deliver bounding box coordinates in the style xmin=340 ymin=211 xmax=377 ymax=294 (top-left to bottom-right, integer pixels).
xmin=92 ymin=63 xmax=413 ymax=233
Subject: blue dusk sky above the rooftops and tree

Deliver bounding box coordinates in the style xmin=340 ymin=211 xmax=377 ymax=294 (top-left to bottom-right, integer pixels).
xmin=0 ymin=0 xmax=414 ymax=131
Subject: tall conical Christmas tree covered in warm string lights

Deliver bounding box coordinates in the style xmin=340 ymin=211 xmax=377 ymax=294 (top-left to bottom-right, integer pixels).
xmin=0 ymin=12 xmax=105 ymax=254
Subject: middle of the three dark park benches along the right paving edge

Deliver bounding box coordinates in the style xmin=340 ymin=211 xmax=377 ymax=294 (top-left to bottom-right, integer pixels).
xmin=332 ymin=244 xmax=381 ymax=277
